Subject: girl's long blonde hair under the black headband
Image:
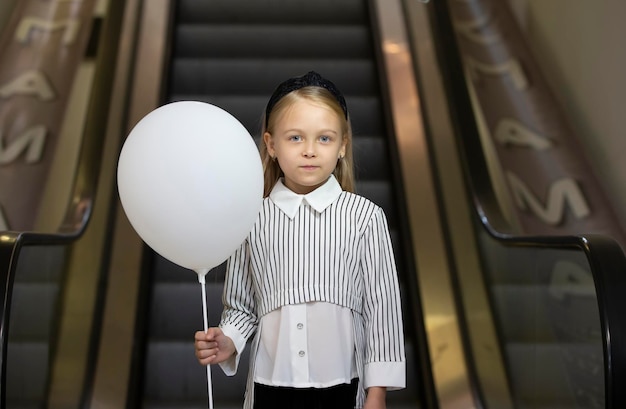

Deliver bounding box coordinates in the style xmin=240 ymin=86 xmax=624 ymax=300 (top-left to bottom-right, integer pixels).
xmin=259 ymin=86 xmax=354 ymax=197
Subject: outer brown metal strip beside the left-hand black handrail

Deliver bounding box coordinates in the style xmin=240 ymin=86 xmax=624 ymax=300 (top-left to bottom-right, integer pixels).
xmin=47 ymin=0 xmax=138 ymax=409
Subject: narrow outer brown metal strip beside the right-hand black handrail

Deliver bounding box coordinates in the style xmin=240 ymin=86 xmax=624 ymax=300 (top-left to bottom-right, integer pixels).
xmin=405 ymin=1 xmax=512 ymax=408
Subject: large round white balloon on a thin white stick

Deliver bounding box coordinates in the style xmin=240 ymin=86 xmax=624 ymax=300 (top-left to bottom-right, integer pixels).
xmin=117 ymin=101 xmax=263 ymax=282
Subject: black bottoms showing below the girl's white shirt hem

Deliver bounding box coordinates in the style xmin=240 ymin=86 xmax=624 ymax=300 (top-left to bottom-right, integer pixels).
xmin=254 ymin=379 xmax=359 ymax=409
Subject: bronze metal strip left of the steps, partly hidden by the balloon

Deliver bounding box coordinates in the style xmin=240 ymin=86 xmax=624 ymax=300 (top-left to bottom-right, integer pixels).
xmin=88 ymin=0 xmax=170 ymax=409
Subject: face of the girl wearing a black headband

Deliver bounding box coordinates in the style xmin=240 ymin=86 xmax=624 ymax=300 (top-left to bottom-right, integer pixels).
xmin=263 ymin=99 xmax=347 ymax=194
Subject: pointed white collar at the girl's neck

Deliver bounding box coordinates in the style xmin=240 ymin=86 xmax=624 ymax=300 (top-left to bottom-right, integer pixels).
xmin=270 ymin=175 xmax=343 ymax=219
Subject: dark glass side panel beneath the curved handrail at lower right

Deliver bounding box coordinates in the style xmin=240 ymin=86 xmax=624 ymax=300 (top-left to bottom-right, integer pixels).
xmin=470 ymin=230 xmax=608 ymax=409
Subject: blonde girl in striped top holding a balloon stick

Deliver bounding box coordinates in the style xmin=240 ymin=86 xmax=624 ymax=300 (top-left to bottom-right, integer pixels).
xmin=195 ymin=72 xmax=405 ymax=409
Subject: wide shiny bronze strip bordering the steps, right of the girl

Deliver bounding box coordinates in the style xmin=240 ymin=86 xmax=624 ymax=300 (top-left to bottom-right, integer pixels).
xmin=375 ymin=0 xmax=474 ymax=409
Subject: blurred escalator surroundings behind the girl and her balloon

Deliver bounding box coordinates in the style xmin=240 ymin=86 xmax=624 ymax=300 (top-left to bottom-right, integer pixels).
xmin=0 ymin=0 xmax=626 ymax=409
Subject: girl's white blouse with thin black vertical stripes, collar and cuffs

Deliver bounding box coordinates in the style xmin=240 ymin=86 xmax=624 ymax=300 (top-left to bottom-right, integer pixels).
xmin=220 ymin=176 xmax=405 ymax=408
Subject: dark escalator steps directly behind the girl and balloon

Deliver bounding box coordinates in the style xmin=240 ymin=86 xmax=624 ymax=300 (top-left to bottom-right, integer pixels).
xmin=130 ymin=0 xmax=421 ymax=408
